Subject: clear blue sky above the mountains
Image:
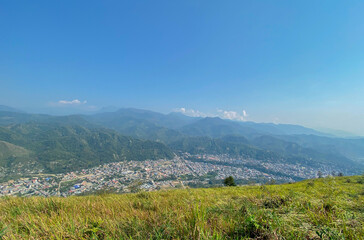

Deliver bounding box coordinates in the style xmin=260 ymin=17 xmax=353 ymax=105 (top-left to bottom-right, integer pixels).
xmin=0 ymin=0 xmax=364 ymax=134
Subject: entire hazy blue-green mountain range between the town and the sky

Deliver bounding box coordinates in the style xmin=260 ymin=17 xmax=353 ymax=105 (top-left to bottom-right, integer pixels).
xmin=0 ymin=106 xmax=364 ymax=182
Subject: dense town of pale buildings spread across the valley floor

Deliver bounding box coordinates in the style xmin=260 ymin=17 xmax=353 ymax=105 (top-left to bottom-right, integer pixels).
xmin=0 ymin=153 xmax=338 ymax=197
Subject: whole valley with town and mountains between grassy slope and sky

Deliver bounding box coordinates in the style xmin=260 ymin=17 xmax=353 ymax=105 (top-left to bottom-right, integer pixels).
xmin=0 ymin=109 xmax=364 ymax=197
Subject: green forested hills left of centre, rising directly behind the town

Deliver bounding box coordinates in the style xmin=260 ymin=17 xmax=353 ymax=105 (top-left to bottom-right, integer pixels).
xmin=0 ymin=123 xmax=173 ymax=177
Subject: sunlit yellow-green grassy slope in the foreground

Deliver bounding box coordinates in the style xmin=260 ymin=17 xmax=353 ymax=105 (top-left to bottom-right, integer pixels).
xmin=0 ymin=176 xmax=364 ymax=239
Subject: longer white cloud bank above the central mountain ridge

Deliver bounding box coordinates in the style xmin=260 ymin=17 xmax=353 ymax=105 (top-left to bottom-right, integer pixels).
xmin=175 ymin=107 xmax=248 ymax=121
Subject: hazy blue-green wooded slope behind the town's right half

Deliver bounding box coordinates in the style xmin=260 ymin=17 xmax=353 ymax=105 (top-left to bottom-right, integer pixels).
xmin=169 ymin=136 xmax=364 ymax=174
